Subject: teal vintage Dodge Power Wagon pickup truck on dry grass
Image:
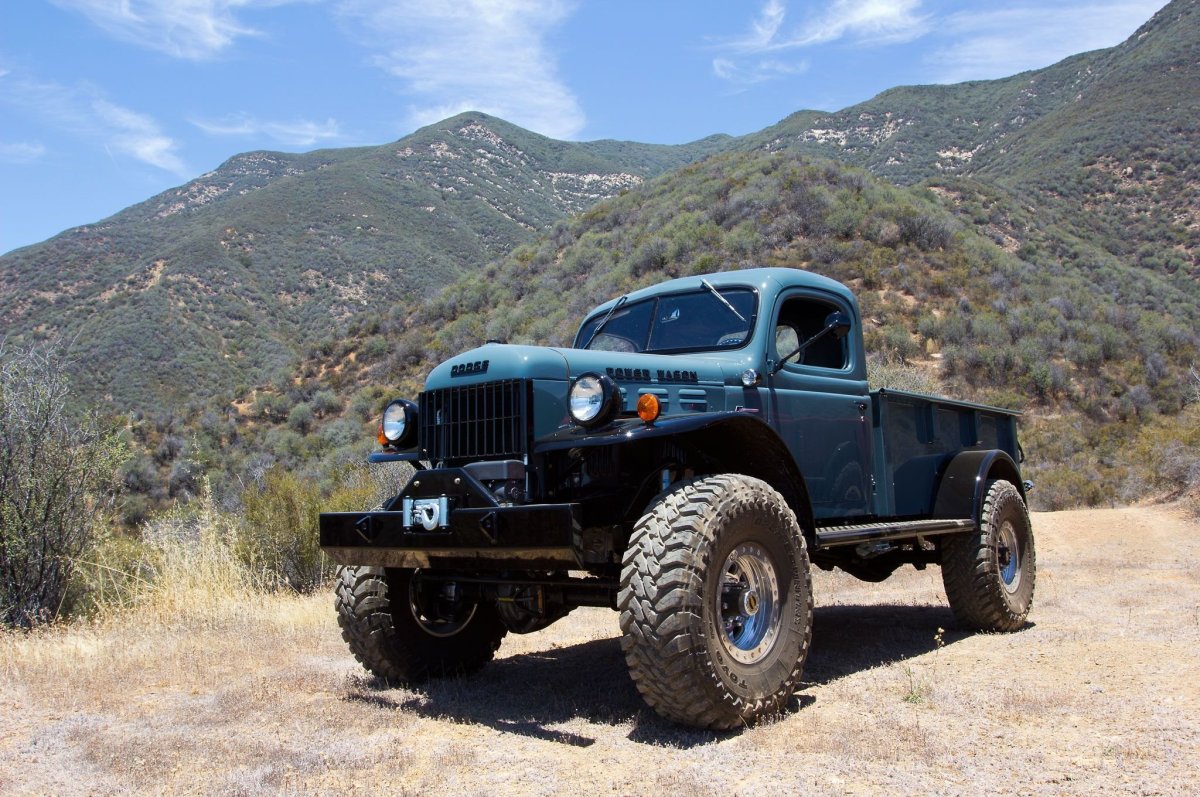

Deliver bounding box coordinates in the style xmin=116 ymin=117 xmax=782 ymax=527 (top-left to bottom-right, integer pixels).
xmin=320 ymin=269 xmax=1034 ymax=729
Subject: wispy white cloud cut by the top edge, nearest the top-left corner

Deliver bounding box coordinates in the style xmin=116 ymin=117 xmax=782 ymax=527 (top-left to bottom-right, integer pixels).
xmin=52 ymin=0 xmax=304 ymax=60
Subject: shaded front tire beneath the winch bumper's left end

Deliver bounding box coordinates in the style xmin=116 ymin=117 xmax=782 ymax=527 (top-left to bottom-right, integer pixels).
xmin=335 ymin=567 xmax=508 ymax=684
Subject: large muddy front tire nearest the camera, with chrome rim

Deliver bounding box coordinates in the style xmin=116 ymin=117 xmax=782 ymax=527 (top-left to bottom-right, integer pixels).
xmin=618 ymin=474 xmax=812 ymax=729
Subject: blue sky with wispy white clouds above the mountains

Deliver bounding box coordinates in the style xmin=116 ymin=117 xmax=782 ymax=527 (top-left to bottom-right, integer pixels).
xmin=0 ymin=0 xmax=1165 ymax=252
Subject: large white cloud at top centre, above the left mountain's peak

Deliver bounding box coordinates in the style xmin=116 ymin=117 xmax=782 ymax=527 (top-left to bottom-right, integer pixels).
xmin=338 ymin=0 xmax=584 ymax=138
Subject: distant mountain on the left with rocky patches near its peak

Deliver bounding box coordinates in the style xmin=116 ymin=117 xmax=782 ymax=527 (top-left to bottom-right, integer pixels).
xmin=0 ymin=114 xmax=722 ymax=407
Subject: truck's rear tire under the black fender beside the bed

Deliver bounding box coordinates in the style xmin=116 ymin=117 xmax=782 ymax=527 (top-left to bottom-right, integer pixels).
xmin=942 ymin=480 xmax=1037 ymax=631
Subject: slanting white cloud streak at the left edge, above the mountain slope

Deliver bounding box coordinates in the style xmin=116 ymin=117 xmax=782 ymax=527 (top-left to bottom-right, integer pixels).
xmin=0 ymin=73 xmax=188 ymax=176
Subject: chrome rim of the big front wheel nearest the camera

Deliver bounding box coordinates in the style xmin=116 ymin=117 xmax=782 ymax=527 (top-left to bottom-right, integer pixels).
xmin=715 ymin=543 xmax=781 ymax=664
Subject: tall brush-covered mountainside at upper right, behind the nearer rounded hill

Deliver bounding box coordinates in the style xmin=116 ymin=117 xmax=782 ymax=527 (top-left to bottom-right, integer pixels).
xmin=742 ymin=0 xmax=1200 ymax=273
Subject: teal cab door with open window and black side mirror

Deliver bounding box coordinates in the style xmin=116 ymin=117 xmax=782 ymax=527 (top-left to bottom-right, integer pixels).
xmin=766 ymin=290 xmax=872 ymax=520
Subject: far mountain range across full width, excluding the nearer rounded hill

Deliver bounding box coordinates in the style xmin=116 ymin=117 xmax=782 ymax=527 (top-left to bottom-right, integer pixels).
xmin=0 ymin=0 xmax=1200 ymax=417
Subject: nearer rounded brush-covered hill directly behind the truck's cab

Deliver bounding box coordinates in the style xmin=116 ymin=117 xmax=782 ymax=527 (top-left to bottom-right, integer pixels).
xmin=259 ymin=151 xmax=1200 ymax=507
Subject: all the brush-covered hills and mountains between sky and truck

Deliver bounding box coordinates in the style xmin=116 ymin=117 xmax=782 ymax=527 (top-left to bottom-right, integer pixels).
xmin=0 ymin=0 xmax=1200 ymax=522
